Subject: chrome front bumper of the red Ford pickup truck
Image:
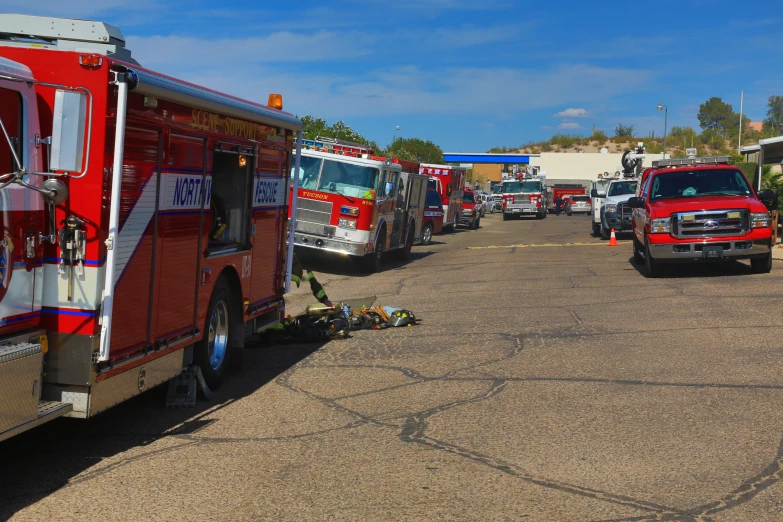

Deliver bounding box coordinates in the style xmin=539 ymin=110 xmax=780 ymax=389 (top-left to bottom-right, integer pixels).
xmin=650 ymin=239 xmax=771 ymax=262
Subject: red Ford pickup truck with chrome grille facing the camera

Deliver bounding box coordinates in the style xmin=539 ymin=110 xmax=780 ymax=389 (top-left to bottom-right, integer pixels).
xmin=628 ymin=157 xmax=774 ymax=277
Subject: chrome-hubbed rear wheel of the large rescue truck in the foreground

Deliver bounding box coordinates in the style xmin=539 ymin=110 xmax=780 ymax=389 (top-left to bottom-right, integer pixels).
xmin=194 ymin=277 xmax=237 ymax=390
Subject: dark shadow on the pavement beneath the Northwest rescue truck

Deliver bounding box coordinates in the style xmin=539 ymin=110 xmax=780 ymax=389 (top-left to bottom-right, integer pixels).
xmin=0 ymin=338 xmax=323 ymax=520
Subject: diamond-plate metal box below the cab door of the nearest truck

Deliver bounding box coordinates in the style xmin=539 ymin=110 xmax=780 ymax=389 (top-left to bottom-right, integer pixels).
xmin=0 ymin=343 xmax=43 ymax=435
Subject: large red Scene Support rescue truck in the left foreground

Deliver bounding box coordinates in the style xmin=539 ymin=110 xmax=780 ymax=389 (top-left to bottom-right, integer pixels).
xmin=0 ymin=15 xmax=301 ymax=440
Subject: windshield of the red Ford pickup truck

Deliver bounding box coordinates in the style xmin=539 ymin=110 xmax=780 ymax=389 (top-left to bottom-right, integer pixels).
xmin=650 ymin=169 xmax=753 ymax=201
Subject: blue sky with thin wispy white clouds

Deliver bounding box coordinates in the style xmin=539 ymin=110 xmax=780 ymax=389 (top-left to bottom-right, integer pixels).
xmin=0 ymin=0 xmax=783 ymax=152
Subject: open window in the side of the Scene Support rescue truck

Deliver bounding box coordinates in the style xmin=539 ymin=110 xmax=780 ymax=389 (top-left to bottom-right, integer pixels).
xmin=209 ymin=148 xmax=253 ymax=253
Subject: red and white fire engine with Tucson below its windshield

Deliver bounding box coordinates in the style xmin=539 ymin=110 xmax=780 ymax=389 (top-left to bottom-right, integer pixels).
xmin=289 ymin=137 xmax=427 ymax=272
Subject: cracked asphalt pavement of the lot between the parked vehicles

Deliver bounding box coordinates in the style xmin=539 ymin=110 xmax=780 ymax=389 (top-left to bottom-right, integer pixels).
xmin=0 ymin=214 xmax=783 ymax=521
